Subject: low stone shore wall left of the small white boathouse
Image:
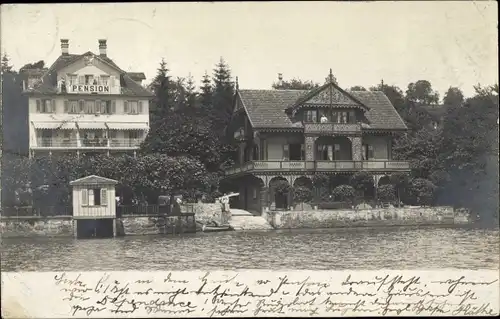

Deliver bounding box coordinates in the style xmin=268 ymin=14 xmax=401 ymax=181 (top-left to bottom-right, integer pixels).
xmin=0 ymin=218 xmax=74 ymax=237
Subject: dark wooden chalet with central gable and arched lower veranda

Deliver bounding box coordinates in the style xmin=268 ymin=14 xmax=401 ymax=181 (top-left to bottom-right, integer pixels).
xmin=224 ymin=72 xmax=410 ymax=214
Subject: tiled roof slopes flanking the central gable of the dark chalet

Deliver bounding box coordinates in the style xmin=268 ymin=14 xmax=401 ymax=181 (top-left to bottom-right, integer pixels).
xmin=238 ymin=90 xmax=407 ymax=130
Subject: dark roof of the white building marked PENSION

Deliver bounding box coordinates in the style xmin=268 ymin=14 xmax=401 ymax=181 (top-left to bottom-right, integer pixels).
xmin=29 ymin=51 xmax=153 ymax=97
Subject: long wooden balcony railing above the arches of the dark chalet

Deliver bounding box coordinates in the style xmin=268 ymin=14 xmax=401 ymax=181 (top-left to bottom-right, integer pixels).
xmin=226 ymin=160 xmax=410 ymax=176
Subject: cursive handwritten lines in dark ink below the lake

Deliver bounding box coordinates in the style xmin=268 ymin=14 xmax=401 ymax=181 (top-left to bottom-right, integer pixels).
xmin=47 ymin=272 xmax=498 ymax=317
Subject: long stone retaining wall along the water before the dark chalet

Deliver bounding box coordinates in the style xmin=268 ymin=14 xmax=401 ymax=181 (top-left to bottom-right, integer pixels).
xmin=265 ymin=207 xmax=470 ymax=229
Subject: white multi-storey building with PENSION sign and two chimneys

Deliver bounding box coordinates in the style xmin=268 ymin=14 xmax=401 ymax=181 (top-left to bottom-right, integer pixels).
xmin=23 ymin=39 xmax=152 ymax=156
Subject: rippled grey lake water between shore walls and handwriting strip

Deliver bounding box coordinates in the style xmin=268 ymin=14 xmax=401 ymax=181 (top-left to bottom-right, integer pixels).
xmin=1 ymin=227 xmax=500 ymax=271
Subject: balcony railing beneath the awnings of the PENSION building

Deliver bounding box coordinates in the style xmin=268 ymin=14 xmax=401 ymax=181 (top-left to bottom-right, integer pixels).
xmin=35 ymin=138 xmax=142 ymax=148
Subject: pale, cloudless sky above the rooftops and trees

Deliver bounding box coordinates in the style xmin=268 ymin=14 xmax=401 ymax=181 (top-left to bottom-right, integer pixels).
xmin=0 ymin=1 xmax=498 ymax=97
